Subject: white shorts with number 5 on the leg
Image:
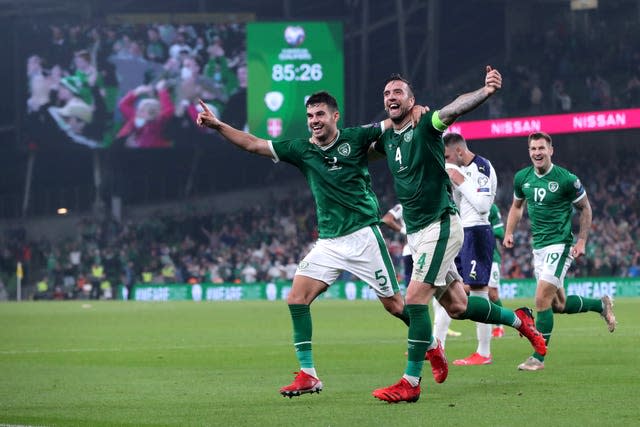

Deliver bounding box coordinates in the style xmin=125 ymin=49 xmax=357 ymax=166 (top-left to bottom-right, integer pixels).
xmin=296 ymin=225 xmax=400 ymax=297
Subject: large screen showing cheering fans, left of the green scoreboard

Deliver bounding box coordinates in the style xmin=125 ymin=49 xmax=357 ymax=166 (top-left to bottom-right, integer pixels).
xmin=25 ymin=14 xmax=253 ymax=148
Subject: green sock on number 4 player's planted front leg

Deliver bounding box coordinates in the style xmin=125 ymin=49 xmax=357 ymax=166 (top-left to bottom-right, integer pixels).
xmin=405 ymin=304 xmax=433 ymax=377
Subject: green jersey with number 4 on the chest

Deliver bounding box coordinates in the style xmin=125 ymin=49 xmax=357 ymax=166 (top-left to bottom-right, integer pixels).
xmin=375 ymin=111 xmax=457 ymax=233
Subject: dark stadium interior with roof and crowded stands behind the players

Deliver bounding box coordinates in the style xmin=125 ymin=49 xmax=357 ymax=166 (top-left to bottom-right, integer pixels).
xmin=0 ymin=0 xmax=640 ymax=298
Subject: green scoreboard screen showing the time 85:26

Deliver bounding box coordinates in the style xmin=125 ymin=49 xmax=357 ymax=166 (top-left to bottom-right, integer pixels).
xmin=247 ymin=22 xmax=344 ymax=138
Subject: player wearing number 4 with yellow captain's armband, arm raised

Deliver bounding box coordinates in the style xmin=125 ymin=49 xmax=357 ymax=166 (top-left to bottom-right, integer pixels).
xmin=373 ymin=66 xmax=546 ymax=402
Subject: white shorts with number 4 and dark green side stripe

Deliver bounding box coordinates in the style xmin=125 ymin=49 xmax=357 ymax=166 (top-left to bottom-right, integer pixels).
xmin=407 ymin=214 xmax=464 ymax=287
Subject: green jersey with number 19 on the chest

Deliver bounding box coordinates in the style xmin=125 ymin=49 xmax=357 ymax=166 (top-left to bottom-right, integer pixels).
xmin=513 ymin=164 xmax=587 ymax=249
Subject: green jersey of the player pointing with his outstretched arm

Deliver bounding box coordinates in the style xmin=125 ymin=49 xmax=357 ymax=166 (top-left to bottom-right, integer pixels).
xmin=272 ymin=125 xmax=381 ymax=239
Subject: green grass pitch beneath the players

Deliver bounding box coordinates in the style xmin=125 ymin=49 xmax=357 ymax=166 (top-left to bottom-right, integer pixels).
xmin=0 ymin=298 xmax=640 ymax=427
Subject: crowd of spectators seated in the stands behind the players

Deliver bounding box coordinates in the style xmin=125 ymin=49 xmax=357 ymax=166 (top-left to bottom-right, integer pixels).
xmin=0 ymin=147 xmax=640 ymax=298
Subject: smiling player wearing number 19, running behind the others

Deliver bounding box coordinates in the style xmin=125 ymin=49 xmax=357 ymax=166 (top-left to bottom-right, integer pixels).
xmin=504 ymin=132 xmax=616 ymax=371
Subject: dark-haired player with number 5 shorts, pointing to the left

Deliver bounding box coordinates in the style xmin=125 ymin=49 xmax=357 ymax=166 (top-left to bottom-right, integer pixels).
xmin=197 ymin=92 xmax=423 ymax=397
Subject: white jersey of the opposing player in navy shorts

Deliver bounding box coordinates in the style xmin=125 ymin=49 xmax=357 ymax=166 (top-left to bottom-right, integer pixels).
xmin=453 ymin=155 xmax=498 ymax=228
